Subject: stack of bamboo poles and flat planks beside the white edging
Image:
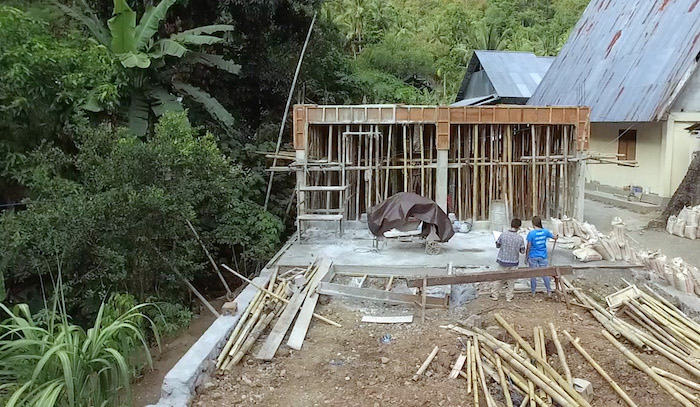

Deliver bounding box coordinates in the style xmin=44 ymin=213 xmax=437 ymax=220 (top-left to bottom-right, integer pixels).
xmin=216 ymin=259 xmax=340 ymax=371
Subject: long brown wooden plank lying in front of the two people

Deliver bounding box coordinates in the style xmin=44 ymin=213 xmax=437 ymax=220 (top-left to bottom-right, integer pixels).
xmin=408 ymin=266 xmax=574 ymax=287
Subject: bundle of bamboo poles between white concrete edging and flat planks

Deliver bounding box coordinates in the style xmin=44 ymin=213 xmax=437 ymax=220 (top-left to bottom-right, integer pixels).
xmin=216 ymin=262 xmax=318 ymax=371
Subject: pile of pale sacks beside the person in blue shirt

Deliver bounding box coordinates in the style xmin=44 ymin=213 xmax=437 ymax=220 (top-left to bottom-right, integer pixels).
xmin=551 ymin=217 xmax=636 ymax=262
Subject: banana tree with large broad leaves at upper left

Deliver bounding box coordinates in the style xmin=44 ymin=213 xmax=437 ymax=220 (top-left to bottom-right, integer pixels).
xmin=55 ymin=0 xmax=240 ymax=136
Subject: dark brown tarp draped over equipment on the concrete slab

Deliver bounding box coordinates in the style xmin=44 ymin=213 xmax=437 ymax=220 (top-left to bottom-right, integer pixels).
xmin=367 ymin=192 xmax=455 ymax=242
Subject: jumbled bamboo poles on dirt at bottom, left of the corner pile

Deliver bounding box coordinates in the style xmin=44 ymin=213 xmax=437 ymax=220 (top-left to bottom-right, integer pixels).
xmin=443 ymin=314 xmax=590 ymax=407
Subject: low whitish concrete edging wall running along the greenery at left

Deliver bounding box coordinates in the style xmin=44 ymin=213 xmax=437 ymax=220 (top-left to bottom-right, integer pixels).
xmin=148 ymin=270 xmax=272 ymax=407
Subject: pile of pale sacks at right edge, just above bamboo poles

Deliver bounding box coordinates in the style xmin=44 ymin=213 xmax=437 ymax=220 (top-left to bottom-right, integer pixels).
xmin=637 ymin=250 xmax=700 ymax=295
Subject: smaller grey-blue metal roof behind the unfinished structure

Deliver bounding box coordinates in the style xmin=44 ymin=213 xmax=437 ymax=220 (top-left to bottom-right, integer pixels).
xmin=457 ymin=51 xmax=554 ymax=101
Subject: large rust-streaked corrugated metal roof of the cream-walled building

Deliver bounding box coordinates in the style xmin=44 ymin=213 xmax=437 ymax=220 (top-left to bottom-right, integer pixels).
xmin=528 ymin=0 xmax=700 ymax=122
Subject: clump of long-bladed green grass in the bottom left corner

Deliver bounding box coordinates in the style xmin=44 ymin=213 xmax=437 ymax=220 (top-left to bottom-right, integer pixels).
xmin=0 ymin=290 xmax=157 ymax=407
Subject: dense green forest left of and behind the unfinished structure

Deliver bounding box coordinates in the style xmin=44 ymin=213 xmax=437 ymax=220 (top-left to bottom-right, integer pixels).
xmin=0 ymin=0 xmax=587 ymax=400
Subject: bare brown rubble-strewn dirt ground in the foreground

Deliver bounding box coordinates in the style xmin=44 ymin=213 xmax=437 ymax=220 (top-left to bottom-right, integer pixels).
xmin=193 ymin=271 xmax=700 ymax=407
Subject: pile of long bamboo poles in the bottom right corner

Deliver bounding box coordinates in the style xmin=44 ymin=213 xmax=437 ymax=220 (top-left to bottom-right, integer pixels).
xmin=565 ymin=282 xmax=700 ymax=406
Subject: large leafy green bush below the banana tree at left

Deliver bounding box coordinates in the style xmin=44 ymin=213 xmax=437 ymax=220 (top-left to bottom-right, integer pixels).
xmin=0 ymin=113 xmax=282 ymax=324
